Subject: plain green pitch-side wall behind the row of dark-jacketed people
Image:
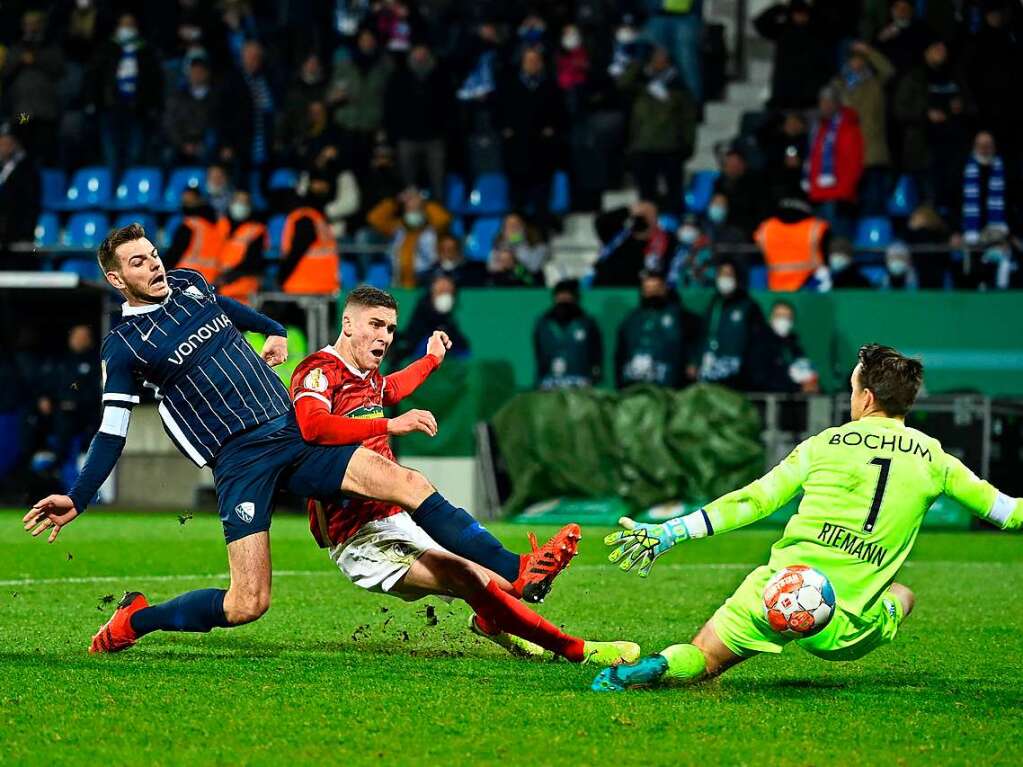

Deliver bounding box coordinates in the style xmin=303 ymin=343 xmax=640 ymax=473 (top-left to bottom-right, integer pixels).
xmin=374 ymin=288 xmax=1023 ymax=396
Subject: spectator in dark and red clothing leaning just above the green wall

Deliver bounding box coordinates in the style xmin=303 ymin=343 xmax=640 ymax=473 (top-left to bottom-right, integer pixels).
xmin=593 ymin=200 xmax=678 ymax=286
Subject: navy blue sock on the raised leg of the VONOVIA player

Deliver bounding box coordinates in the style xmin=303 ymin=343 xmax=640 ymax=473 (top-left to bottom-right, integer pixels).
xmin=412 ymin=493 xmax=520 ymax=582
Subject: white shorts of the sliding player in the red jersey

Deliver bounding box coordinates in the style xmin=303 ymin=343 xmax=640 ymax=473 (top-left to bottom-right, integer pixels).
xmin=329 ymin=511 xmax=444 ymax=601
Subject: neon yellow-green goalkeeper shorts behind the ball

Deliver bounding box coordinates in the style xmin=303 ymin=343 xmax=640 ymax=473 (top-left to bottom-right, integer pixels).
xmin=713 ymin=567 xmax=902 ymax=661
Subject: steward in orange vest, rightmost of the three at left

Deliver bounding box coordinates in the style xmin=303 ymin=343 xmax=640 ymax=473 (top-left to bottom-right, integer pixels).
xmin=280 ymin=196 xmax=341 ymax=295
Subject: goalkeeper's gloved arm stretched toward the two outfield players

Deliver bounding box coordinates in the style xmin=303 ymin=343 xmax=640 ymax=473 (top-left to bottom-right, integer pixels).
xmin=604 ymin=438 xmax=813 ymax=578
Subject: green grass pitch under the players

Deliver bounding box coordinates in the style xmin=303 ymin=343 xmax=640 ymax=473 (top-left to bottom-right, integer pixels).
xmin=0 ymin=509 xmax=1023 ymax=767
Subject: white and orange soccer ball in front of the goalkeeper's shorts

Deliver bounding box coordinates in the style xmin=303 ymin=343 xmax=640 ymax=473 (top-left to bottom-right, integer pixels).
xmin=764 ymin=565 xmax=835 ymax=636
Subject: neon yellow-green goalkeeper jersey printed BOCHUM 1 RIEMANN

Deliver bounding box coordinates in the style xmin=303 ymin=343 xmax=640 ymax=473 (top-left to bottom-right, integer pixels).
xmin=704 ymin=417 xmax=1023 ymax=614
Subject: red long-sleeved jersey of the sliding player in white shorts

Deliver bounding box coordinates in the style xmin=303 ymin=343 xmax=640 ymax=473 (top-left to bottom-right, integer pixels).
xmin=292 ymin=346 xmax=440 ymax=547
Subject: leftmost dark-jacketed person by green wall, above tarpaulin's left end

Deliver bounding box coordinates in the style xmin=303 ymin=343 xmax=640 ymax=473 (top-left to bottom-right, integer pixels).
xmin=533 ymin=279 xmax=604 ymax=390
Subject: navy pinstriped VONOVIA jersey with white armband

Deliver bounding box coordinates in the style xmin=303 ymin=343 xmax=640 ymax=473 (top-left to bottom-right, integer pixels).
xmin=69 ymin=269 xmax=292 ymax=512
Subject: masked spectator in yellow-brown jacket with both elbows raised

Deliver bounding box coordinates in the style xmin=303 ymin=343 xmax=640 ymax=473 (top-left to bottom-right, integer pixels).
xmin=366 ymin=186 xmax=451 ymax=287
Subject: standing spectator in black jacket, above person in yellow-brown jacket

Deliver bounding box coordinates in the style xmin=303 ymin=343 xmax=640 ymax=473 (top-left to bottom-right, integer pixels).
xmin=384 ymin=44 xmax=451 ymax=199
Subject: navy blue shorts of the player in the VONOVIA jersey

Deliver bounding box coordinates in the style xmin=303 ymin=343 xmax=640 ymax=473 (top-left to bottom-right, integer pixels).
xmin=213 ymin=413 xmax=359 ymax=543
